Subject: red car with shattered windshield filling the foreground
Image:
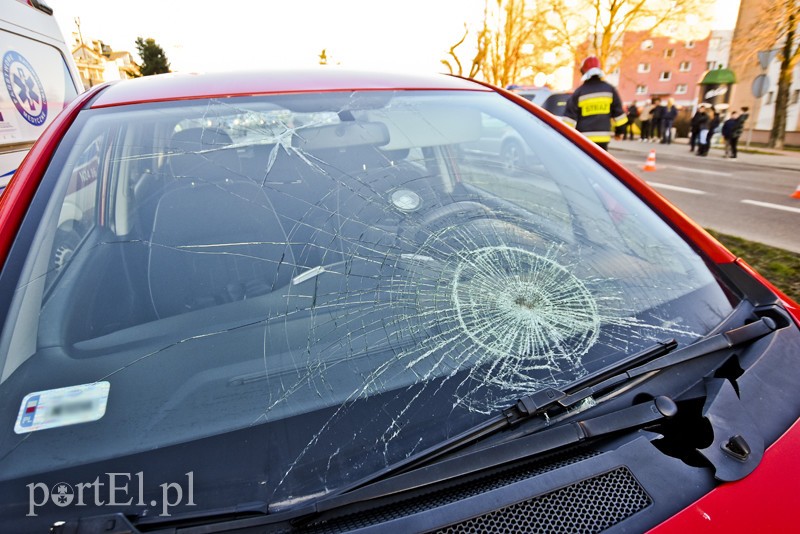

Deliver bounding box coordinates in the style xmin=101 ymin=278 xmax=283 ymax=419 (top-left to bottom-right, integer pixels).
xmin=0 ymin=68 xmax=800 ymax=533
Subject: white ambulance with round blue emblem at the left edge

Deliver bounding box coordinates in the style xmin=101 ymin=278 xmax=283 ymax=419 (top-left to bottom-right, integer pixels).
xmin=0 ymin=0 xmax=83 ymax=193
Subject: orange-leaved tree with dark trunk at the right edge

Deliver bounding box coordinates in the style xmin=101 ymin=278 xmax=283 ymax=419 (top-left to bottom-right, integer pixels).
xmin=735 ymin=0 xmax=800 ymax=149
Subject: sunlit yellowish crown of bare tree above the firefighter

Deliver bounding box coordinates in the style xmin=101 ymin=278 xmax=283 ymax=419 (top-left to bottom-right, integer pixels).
xmin=538 ymin=0 xmax=711 ymax=75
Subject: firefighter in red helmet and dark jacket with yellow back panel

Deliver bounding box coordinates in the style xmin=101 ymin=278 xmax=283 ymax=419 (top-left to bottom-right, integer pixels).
xmin=561 ymin=56 xmax=628 ymax=150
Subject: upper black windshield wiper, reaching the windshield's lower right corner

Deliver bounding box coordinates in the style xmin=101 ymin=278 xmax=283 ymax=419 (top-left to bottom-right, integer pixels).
xmin=306 ymin=317 xmax=777 ymax=500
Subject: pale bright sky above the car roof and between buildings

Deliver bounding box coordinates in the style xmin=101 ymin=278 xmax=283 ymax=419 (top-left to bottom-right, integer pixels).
xmin=47 ymin=0 xmax=740 ymax=77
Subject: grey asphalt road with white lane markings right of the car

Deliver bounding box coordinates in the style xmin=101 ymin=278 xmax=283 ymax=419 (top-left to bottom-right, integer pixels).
xmin=610 ymin=141 xmax=800 ymax=253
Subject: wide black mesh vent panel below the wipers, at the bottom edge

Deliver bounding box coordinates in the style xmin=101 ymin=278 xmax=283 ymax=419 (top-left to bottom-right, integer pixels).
xmin=436 ymin=467 xmax=652 ymax=534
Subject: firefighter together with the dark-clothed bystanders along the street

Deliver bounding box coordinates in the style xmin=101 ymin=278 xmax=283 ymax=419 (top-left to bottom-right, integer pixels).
xmin=563 ymin=56 xmax=749 ymax=158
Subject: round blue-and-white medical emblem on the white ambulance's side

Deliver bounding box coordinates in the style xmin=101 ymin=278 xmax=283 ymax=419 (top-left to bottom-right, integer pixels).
xmin=3 ymin=50 xmax=47 ymax=126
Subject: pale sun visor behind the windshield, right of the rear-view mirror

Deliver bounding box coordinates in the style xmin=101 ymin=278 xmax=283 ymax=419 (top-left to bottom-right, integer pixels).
xmin=369 ymin=104 xmax=481 ymax=150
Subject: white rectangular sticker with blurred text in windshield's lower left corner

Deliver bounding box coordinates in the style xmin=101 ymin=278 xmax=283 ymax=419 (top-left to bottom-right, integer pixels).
xmin=14 ymin=382 xmax=111 ymax=434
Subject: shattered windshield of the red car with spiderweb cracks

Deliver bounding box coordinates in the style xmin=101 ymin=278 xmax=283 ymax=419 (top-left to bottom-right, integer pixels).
xmin=0 ymin=91 xmax=731 ymax=508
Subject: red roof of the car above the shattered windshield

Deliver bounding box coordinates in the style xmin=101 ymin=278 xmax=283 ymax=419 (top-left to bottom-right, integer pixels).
xmin=86 ymin=66 xmax=492 ymax=108
